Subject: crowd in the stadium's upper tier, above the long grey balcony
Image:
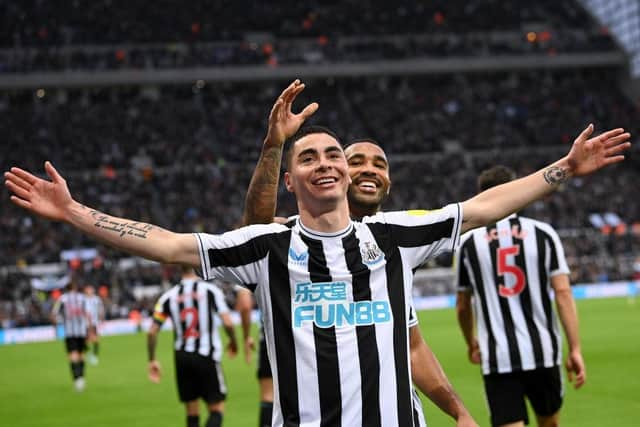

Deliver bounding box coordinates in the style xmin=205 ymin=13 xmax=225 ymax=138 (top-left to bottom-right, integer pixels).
xmin=0 ymin=0 xmax=616 ymax=74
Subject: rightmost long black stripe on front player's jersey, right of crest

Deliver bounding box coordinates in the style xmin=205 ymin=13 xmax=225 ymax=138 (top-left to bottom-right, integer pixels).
xmin=367 ymin=223 xmax=412 ymax=426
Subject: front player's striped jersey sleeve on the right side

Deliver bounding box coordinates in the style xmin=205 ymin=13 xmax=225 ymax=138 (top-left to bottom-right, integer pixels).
xmin=366 ymin=203 xmax=463 ymax=268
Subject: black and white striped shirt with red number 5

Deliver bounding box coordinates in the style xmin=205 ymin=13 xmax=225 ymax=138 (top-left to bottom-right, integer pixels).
xmin=454 ymin=215 xmax=569 ymax=374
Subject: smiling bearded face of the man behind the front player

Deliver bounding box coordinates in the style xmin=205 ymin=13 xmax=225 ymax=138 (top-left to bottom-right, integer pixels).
xmin=345 ymin=142 xmax=391 ymax=217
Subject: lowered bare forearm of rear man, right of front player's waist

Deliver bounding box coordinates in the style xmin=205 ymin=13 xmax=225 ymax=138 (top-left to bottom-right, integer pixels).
xmin=409 ymin=326 xmax=478 ymax=427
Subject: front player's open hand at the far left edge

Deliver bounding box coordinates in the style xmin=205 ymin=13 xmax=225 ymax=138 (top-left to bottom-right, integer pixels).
xmin=4 ymin=162 xmax=74 ymax=221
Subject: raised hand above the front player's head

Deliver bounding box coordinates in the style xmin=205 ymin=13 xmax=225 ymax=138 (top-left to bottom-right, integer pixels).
xmin=265 ymin=79 xmax=318 ymax=146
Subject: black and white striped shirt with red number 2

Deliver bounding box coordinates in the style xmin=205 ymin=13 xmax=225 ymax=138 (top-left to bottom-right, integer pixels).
xmin=153 ymin=279 xmax=229 ymax=362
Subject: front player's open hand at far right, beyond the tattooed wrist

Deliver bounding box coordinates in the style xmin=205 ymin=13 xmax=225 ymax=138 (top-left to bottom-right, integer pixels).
xmin=567 ymin=124 xmax=631 ymax=176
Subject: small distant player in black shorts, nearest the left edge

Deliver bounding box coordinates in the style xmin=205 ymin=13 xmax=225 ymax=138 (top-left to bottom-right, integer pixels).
xmin=51 ymin=279 xmax=89 ymax=391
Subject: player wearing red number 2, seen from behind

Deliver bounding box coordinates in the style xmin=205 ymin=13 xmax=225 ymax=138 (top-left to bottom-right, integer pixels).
xmin=147 ymin=266 xmax=237 ymax=427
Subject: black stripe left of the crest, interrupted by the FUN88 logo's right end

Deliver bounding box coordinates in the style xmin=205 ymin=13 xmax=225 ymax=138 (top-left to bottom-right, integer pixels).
xmin=342 ymin=231 xmax=381 ymax=427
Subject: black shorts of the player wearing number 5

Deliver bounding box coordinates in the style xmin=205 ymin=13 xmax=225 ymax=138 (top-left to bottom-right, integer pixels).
xmin=484 ymin=366 xmax=563 ymax=426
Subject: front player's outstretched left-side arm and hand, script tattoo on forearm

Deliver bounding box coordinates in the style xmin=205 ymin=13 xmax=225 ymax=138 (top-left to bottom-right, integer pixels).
xmin=4 ymin=162 xmax=200 ymax=267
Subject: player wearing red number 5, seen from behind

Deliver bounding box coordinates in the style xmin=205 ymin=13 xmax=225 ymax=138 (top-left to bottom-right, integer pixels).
xmin=454 ymin=166 xmax=586 ymax=427
